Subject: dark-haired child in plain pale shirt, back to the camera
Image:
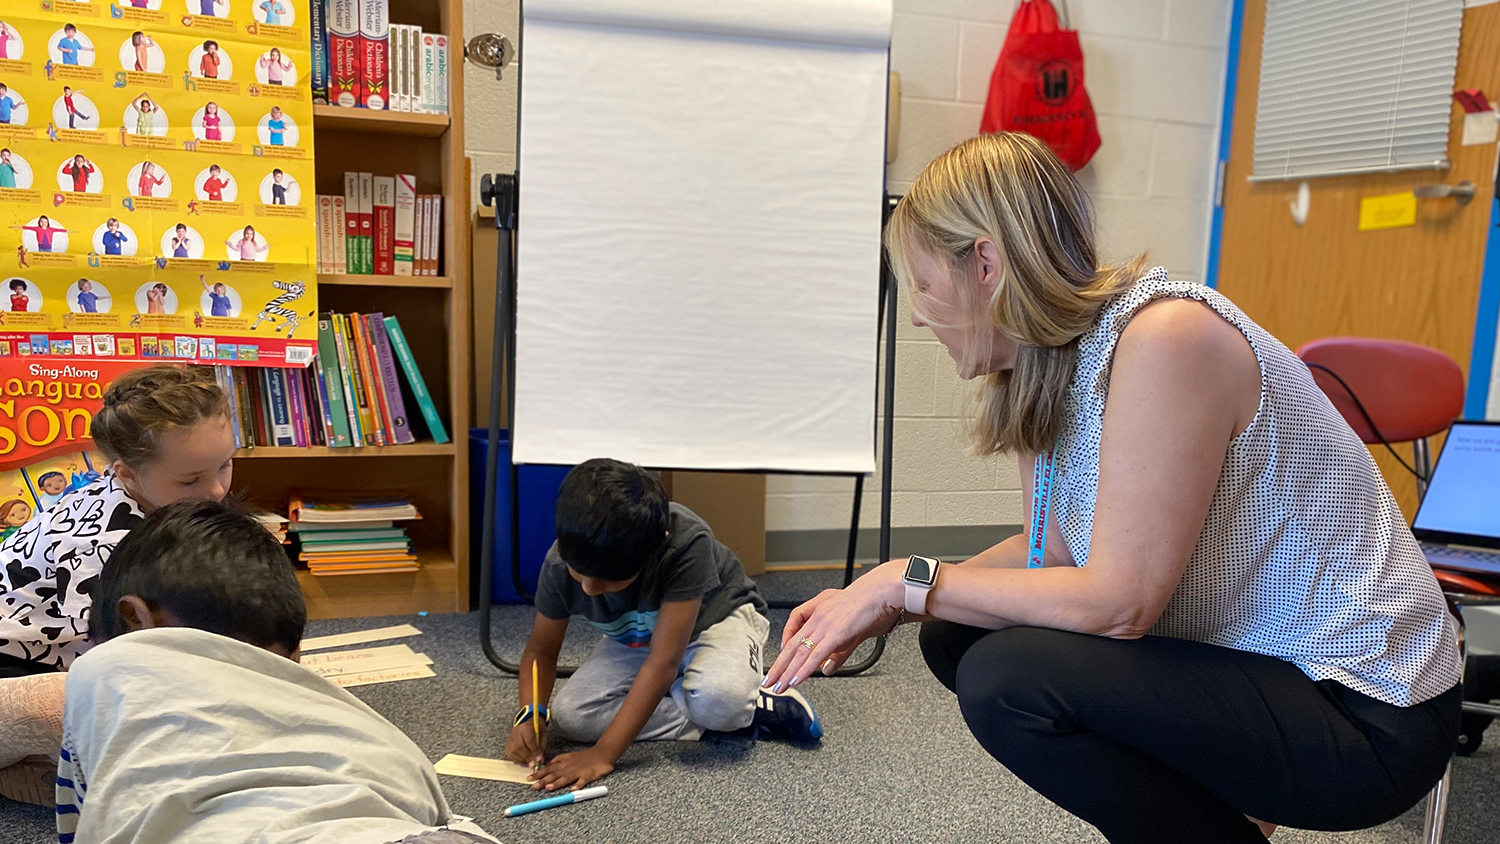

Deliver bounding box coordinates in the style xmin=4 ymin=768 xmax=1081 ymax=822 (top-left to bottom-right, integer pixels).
xmin=57 ymin=499 xmax=492 ymax=844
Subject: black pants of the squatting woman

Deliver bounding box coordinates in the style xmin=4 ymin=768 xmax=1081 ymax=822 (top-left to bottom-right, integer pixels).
xmin=921 ymin=622 xmax=1461 ymax=844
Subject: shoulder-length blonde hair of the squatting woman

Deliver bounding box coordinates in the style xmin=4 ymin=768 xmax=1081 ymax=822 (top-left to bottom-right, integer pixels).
xmin=885 ymin=132 xmax=1146 ymax=454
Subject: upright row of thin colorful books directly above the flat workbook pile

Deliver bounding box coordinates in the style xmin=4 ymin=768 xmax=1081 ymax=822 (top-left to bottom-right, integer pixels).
xmin=215 ymin=313 xmax=449 ymax=448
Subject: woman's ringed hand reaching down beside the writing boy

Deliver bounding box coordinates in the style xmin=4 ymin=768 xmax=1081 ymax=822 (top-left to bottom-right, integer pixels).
xmin=765 ymin=561 xmax=906 ymax=690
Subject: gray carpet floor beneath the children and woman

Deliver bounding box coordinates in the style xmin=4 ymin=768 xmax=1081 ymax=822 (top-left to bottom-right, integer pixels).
xmin=0 ymin=573 xmax=1500 ymax=844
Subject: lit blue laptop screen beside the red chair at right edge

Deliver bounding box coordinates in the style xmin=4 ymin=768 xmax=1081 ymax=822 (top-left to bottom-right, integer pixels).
xmin=1412 ymin=423 xmax=1500 ymax=546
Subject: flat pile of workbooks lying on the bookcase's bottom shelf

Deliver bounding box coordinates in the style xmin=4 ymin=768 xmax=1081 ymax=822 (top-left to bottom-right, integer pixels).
xmin=290 ymin=492 xmax=422 ymax=576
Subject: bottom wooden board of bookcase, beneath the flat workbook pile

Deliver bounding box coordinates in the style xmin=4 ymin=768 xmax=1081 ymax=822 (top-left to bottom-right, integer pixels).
xmin=297 ymin=549 xmax=453 ymax=619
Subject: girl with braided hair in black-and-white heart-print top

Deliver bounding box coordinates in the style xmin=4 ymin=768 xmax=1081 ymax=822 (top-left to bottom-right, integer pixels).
xmin=0 ymin=364 xmax=234 ymax=805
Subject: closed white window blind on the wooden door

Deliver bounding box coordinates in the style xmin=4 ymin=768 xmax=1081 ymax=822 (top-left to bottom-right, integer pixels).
xmin=1251 ymin=0 xmax=1464 ymax=181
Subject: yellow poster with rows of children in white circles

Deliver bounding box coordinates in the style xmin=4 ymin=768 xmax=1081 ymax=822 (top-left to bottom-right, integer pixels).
xmin=0 ymin=0 xmax=318 ymax=369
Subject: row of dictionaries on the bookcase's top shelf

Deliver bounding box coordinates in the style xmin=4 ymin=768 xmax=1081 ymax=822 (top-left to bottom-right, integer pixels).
xmin=311 ymin=0 xmax=450 ymax=114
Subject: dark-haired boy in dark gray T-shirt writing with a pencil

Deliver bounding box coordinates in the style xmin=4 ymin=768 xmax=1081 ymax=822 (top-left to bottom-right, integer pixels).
xmin=506 ymin=459 xmax=822 ymax=790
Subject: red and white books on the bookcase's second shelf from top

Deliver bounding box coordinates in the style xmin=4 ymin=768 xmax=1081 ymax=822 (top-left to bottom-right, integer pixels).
xmin=318 ymin=172 xmax=443 ymax=276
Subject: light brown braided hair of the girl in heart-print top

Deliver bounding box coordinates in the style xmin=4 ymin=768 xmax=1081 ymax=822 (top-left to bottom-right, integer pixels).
xmin=90 ymin=364 xmax=230 ymax=466
